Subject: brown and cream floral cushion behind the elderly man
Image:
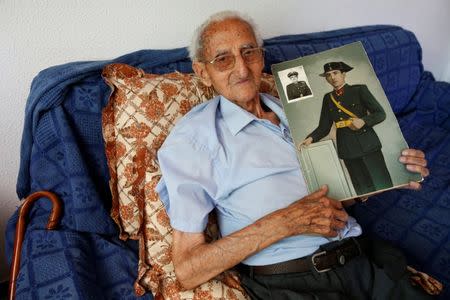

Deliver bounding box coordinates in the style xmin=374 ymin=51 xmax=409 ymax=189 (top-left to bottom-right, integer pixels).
xmin=102 ymin=64 xmax=276 ymax=299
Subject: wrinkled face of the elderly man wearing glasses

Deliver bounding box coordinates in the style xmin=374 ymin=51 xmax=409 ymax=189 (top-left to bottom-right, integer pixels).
xmin=193 ymin=19 xmax=264 ymax=106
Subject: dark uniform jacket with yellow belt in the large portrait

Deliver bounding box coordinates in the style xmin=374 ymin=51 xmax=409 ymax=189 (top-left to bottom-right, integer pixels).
xmin=309 ymin=84 xmax=386 ymax=159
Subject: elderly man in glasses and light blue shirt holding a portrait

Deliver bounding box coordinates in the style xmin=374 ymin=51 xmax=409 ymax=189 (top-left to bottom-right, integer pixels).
xmin=157 ymin=12 xmax=428 ymax=299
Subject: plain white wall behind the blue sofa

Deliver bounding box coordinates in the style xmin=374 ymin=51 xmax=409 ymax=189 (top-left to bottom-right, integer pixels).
xmin=0 ymin=0 xmax=450 ymax=281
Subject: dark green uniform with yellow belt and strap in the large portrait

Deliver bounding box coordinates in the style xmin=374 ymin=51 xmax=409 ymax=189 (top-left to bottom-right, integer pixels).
xmin=308 ymin=84 xmax=392 ymax=195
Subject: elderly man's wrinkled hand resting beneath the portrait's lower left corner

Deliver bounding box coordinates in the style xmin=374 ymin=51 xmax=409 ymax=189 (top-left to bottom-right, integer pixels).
xmin=282 ymin=186 xmax=348 ymax=237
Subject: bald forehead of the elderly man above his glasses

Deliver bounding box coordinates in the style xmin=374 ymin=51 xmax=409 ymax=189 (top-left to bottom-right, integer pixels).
xmin=202 ymin=19 xmax=257 ymax=55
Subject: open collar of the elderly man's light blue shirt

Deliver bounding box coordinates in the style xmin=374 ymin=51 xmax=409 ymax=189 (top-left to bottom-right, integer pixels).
xmin=220 ymin=94 xmax=287 ymax=135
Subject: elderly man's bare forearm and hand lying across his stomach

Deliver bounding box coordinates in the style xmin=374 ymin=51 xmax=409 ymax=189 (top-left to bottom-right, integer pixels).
xmin=172 ymin=186 xmax=348 ymax=289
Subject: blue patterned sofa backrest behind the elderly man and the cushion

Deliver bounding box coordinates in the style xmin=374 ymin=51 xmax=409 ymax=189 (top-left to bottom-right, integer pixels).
xmin=17 ymin=26 xmax=423 ymax=234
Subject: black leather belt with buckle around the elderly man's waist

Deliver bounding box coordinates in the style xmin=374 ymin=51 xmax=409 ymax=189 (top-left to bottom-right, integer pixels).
xmin=238 ymin=238 xmax=365 ymax=275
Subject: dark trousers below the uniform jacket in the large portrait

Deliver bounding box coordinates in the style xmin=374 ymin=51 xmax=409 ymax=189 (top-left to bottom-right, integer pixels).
xmin=344 ymin=150 xmax=392 ymax=195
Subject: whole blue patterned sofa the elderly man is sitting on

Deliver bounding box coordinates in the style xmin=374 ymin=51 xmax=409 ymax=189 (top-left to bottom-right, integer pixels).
xmin=6 ymin=25 xmax=450 ymax=299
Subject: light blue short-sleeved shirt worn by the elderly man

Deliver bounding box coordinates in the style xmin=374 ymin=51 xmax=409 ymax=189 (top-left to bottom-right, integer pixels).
xmin=156 ymin=94 xmax=361 ymax=265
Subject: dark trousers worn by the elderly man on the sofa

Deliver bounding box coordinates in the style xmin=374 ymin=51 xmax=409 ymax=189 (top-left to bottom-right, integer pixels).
xmin=241 ymin=241 xmax=433 ymax=300
